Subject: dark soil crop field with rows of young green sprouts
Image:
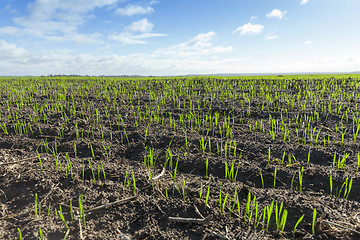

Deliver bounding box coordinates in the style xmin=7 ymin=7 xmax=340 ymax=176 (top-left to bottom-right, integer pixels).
xmin=0 ymin=75 xmax=360 ymax=239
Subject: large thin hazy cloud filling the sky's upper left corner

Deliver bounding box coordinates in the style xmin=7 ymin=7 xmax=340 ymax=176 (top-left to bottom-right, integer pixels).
xmin=0 ymin=0 xmax=120 ymax=43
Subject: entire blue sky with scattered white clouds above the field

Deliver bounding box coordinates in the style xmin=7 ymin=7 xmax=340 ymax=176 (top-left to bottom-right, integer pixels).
xmin=0 ymin=0 xmax=360 ymax=75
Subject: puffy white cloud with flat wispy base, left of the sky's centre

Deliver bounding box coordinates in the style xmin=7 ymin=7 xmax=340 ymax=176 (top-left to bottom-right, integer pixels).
xmin=108 ymin=18 xmax=166 ymax=45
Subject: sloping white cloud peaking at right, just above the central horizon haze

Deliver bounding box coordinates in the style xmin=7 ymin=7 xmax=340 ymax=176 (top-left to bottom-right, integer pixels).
xmin=155 ymin=32 xmax=232 ymax=57
